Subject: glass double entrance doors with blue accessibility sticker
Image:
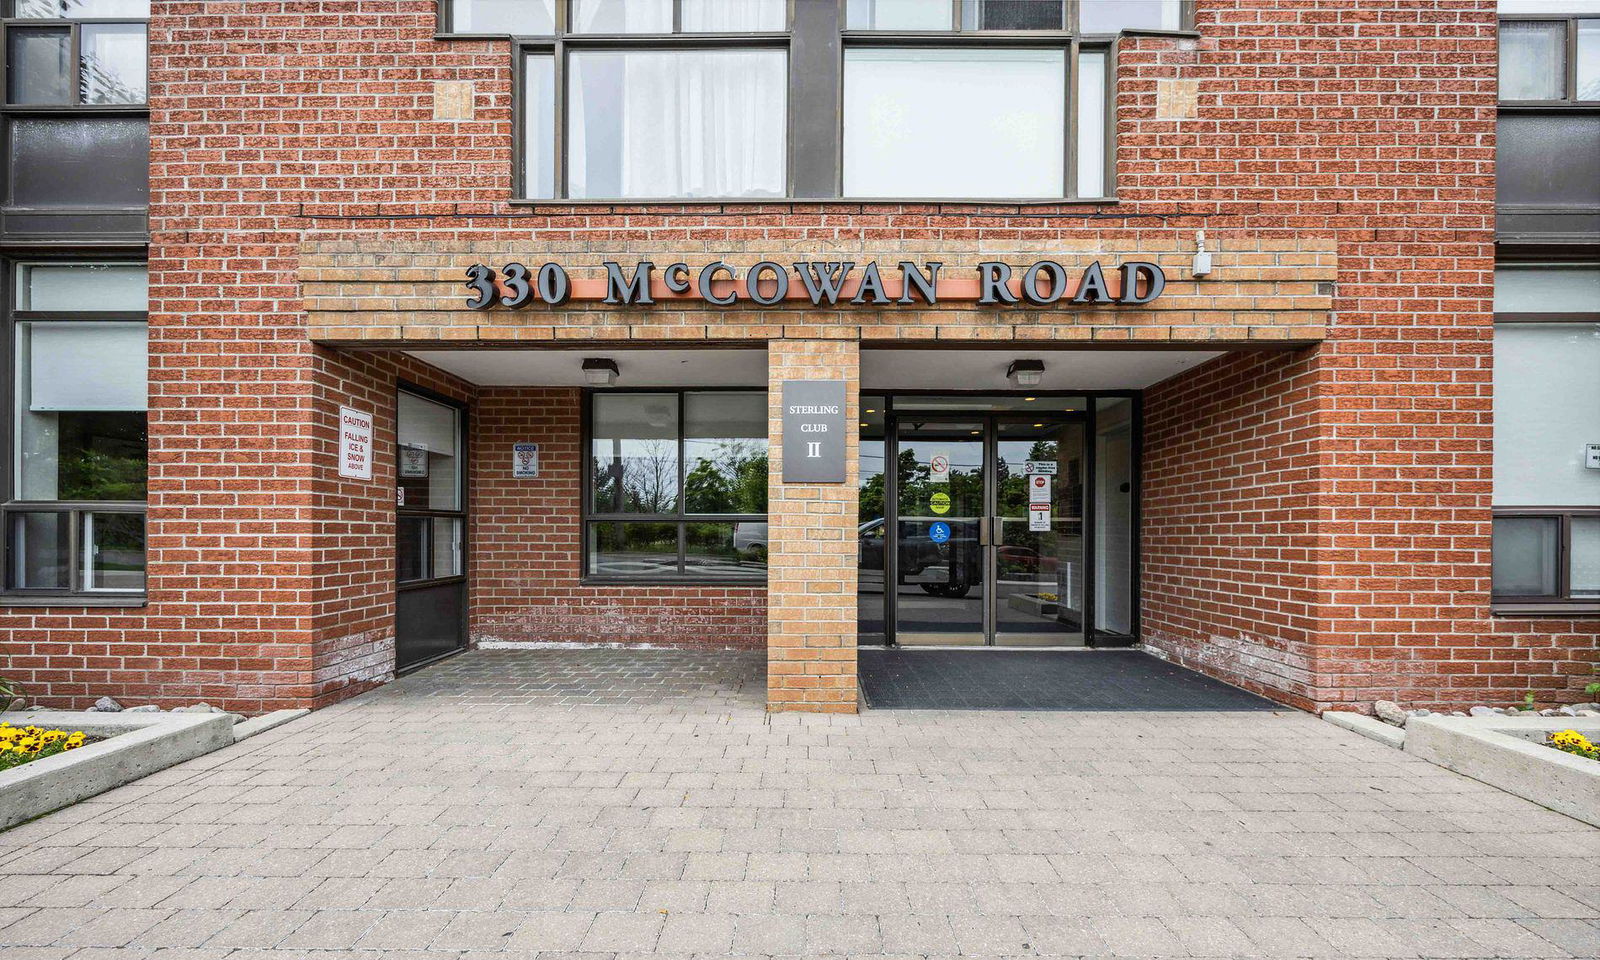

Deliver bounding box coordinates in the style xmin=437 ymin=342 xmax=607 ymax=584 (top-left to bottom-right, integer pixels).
xmin=885 ymin=413 xmax=1086 ymax=646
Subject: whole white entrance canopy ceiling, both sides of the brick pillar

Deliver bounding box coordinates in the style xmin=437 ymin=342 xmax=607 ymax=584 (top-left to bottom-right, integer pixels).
xmin=410 ymin=344 xmax=1221 ymax=390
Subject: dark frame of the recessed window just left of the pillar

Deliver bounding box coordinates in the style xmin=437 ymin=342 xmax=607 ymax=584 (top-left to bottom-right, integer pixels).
xmin=578 ymin=386 xmax=771 ymax=589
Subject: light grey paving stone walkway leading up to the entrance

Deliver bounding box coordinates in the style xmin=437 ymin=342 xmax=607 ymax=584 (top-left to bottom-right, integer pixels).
xmin=0 ymin=651 xmax=1600 ymax=960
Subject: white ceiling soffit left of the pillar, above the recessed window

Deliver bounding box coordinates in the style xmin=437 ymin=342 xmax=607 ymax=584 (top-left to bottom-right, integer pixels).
xmin=408 ymin=347 xmax=766 ymax=389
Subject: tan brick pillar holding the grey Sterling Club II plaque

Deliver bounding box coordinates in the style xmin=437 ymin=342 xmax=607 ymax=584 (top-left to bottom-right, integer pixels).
xmin=766 ymin=339 xmax=861 ymax=714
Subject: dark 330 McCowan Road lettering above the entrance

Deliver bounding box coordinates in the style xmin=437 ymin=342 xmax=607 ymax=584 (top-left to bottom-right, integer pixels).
xmin=467 ymin=261 xmax=1166 ymax=310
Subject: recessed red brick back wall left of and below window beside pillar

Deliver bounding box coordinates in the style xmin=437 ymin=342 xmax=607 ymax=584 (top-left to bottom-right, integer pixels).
xmin=470 ymin=387 xmax=766 ymax=648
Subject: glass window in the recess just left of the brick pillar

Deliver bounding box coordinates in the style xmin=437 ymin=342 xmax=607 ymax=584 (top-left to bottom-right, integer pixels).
xmin=584 ymin=390 xmax=766 ymax=581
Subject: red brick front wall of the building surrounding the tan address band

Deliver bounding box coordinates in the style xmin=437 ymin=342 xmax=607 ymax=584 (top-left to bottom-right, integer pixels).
xmin=9 ymin=0 xmax=1600 ymax=710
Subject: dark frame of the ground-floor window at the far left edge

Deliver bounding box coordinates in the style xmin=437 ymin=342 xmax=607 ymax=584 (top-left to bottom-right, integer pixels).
xmin=0 ymin=251 xmax=150 ymax=606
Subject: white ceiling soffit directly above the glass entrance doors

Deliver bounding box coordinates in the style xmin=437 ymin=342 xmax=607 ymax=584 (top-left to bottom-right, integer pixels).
xmin=861 ymin=344 xmax=1222 ymax=390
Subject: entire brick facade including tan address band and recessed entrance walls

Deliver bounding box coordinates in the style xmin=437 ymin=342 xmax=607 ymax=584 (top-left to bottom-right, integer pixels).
xmin=0 ymin=0 xmax=1600 ymax=712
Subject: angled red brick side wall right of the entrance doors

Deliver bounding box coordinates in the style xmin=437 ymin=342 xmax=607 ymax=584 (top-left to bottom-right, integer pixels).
xmin=1139 ymin=349 xmax=1322 ymax=707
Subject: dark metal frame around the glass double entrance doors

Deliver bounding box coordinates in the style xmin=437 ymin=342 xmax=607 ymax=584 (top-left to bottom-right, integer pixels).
xmin=862 ymin=390 xmax=1144 ymax=650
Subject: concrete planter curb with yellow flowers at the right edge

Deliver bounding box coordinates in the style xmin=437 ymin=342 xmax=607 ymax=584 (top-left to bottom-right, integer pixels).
xmin=1405 ymin=717 xmax=1600 ymax=827
